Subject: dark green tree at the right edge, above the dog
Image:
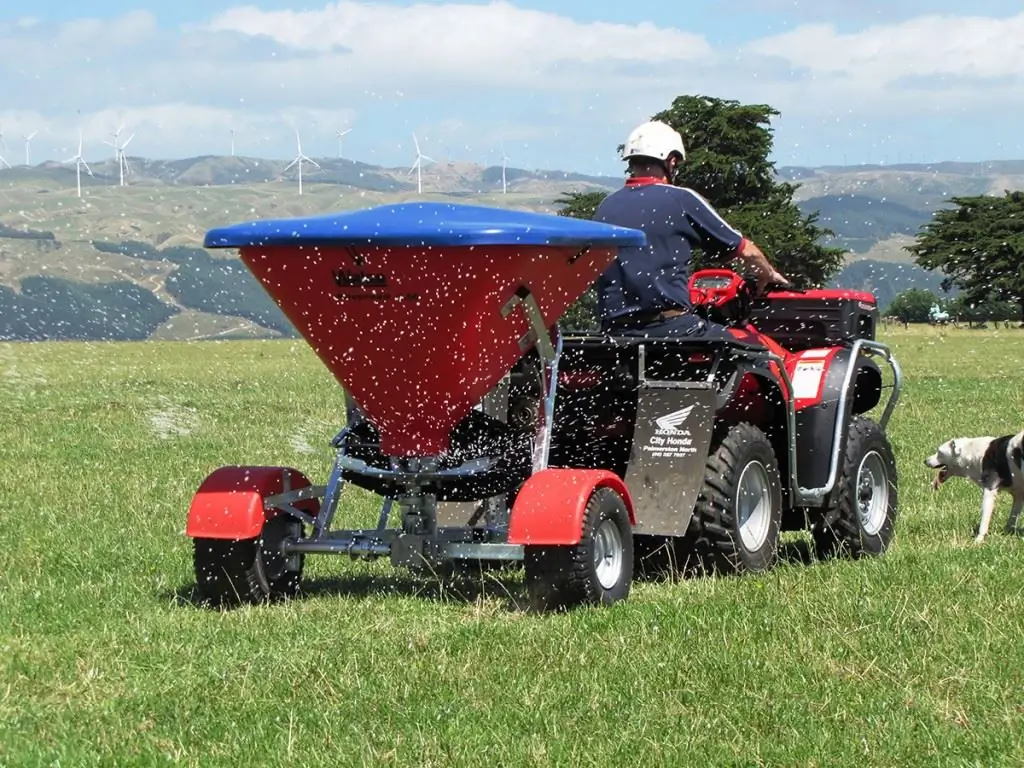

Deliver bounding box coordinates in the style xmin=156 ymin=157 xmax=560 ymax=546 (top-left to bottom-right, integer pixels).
xmin=906 ymin=191 xmax=1024 ymax=319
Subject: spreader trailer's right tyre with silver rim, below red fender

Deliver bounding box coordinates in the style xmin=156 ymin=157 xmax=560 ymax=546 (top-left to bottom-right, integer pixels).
xmin=523 ymin=488 xmax=633 ymax=610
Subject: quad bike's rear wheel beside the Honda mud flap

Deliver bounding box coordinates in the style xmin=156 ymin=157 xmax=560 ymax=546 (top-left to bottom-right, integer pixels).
xmin=687 ymin=423 xmax=782 ymax=574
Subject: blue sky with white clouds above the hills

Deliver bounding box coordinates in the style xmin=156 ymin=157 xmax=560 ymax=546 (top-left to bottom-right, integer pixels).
xmin=0 ymin=0 xmax=1024 ymax=174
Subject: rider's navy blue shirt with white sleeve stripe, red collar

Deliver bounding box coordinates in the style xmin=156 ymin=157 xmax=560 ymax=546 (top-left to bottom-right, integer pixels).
xmin=594 ymin=177 xmax=743 ymax=319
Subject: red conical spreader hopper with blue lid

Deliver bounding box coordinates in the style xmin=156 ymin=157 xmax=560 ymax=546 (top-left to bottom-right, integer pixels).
xmin=204 ymin=203 xmax=646 ymax=457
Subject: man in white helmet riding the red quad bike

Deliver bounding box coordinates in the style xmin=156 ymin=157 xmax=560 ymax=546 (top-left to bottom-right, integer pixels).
xmin=594 ymin=121 xmax=787 ymax=336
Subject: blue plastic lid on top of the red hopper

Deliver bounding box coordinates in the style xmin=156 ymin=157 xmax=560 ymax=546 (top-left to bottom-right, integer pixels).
xmin=203 ymin=203 xmax=647 ymax=248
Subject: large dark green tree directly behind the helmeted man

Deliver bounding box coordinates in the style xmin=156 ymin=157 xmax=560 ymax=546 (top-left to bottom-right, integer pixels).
xmin=558 ymin=95 xmax=845 ymax=331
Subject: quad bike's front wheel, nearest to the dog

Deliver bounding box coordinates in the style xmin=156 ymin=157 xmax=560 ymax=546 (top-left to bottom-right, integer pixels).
xmin=812 ymin=416 xmax=898 ymax=559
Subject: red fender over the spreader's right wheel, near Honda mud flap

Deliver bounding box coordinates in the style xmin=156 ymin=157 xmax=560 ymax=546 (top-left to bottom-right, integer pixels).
xmin=508 ymin=469 xmax=636 ymax=545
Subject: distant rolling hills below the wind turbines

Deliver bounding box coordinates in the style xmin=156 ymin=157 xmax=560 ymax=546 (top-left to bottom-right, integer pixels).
xmin=0 ymin=156 xmax=1024 ymax=339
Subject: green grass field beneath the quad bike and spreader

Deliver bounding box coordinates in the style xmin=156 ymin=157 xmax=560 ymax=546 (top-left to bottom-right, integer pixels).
xmin=0 ymin=328 xmax=1024 ymax=767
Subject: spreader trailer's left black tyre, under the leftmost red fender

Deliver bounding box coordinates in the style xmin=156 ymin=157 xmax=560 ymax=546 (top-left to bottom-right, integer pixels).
xmin=194 ymin=513 xmax=305 ymax=605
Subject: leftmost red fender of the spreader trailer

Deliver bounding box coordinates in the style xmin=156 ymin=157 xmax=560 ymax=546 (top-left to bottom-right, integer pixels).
xmin=185 ymin=467 xmax=319 ymax=540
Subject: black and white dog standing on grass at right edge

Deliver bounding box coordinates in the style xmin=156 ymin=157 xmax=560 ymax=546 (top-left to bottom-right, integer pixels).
xmin=925 ymin=432 xmax=1024 ymax=543
